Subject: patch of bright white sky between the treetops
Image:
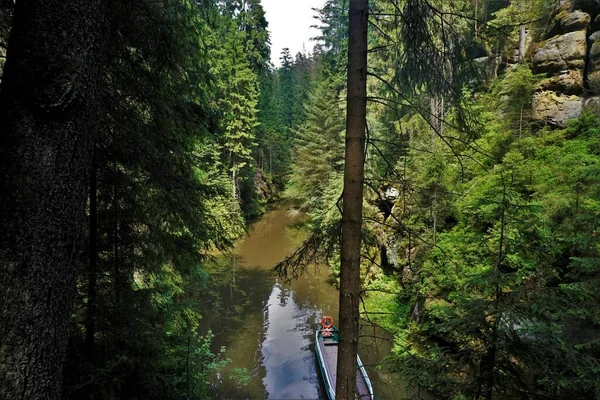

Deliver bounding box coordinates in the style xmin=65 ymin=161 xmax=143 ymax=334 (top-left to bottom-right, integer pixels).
xmin=261 ymin=0 xmax=325 ymax=67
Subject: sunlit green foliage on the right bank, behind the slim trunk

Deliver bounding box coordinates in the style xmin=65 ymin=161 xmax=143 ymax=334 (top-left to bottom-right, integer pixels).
xmin=281 ymin=0 xmax=600 ymax=399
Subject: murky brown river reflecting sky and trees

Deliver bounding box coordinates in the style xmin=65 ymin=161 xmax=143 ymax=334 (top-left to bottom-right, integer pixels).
xmin=203 ymin=205 xmax=414 ymax=399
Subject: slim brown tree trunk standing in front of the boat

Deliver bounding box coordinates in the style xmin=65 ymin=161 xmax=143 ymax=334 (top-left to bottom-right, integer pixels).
xmin=336 ymin=0 xmax=368 ymax=399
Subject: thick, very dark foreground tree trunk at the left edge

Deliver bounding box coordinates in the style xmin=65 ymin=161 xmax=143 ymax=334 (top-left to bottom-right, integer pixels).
xmin=0 ymin=0 xmax=108 ymax=399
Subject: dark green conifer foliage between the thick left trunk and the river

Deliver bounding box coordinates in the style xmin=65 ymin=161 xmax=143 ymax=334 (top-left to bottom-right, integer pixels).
xmin=65 ymin=0 xmax=268 ymax=399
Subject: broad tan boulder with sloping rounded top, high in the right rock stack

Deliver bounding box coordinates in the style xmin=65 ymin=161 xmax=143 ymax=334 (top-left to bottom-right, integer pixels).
xmin=533 ymin=30 xmax=587 ymax=75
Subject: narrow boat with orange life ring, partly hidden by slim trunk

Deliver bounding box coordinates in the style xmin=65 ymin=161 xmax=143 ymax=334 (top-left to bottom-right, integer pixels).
xmin=315 ymin=316 xmax=375 ymax=400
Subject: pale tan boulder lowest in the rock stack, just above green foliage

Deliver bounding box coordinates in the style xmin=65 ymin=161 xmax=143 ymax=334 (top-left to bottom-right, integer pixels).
xmin=532 ymin=91 xmax=583 ymax=127
